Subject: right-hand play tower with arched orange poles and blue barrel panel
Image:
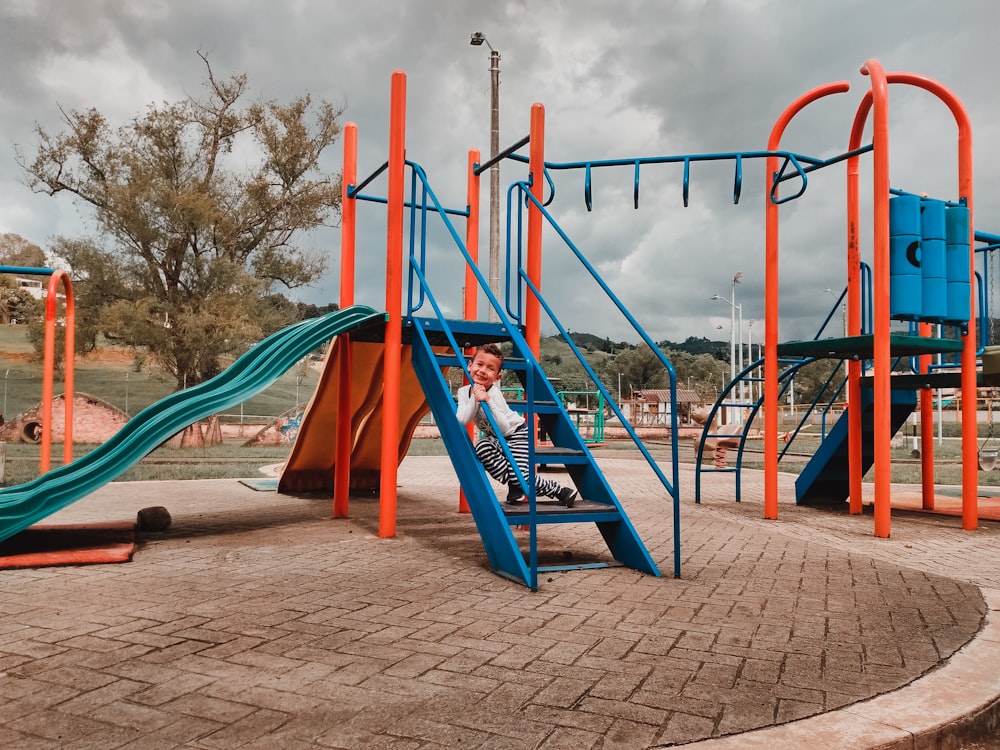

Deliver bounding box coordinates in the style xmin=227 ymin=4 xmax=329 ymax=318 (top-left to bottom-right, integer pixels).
xmin=696 ymin=60 xmax=998 ymax=537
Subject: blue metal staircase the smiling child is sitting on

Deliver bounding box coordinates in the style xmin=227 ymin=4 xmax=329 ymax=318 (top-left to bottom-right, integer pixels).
xmin=408 ymin=318 xmax=660 ymax=590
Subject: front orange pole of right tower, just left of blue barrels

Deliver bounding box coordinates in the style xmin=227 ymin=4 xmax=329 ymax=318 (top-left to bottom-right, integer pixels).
xmin=861 ymin=60 xmax=892 ymax=538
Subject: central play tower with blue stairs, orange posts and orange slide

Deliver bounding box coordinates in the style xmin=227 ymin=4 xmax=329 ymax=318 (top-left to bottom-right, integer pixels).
xmin=279 ymin=72 xmax=679 ymax=589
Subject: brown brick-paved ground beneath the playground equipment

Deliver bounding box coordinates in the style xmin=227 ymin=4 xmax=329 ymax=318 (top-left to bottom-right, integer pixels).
xmin=0 ymin=457 xmax=1000 ymax=750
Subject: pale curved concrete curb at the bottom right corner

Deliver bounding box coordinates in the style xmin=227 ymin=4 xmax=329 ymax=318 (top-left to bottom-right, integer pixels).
xmin=660 ymin=589 xmax=1000 ymax=750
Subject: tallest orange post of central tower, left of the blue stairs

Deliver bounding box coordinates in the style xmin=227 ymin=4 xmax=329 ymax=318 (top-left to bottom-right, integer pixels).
xmin=378 ymin=70 xmax=406 ymax=537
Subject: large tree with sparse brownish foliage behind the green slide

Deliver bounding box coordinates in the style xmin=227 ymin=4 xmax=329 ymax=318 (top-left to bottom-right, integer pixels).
xmin=19 ymin=53 xmax=341 ymax=387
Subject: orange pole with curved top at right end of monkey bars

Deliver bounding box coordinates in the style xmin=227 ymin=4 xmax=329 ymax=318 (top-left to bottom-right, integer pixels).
xmin=764 ymin=81 xmax=850 ymax=519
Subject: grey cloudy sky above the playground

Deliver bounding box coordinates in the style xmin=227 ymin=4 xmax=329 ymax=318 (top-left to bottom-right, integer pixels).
xmin=0 ymin=0 xmax=1000 ymax=342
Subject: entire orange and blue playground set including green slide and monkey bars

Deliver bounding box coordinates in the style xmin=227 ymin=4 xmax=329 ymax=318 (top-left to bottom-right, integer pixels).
xmin=0 ymin=55 xmax=982 ymax=589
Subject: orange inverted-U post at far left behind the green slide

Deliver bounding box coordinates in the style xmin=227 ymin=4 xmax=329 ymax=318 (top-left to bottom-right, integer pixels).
xmin=39 ymin=269 xmax=76 ymax=474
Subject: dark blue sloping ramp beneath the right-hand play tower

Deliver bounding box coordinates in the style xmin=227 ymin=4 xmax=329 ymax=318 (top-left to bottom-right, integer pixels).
xmin=795 ymin=388 xmax=917 ymax=506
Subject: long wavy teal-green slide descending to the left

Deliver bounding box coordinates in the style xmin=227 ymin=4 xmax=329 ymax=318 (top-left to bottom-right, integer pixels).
xmin=0 ymin=305 xmax=385 ymax=541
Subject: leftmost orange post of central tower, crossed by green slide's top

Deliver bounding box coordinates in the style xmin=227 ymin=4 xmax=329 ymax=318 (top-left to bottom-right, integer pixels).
xmin=331 ymin=122 xmax=358 ymax=518
